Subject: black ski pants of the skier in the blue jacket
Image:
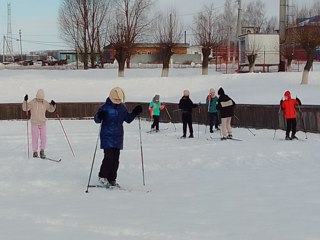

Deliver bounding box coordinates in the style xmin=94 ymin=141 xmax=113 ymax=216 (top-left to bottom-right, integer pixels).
xmin=99 ymin=148 xmax=120 ymax=182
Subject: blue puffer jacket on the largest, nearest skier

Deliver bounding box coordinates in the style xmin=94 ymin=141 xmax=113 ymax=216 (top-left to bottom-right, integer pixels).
xmin=94 ymin=98 xmax=136 ymax=149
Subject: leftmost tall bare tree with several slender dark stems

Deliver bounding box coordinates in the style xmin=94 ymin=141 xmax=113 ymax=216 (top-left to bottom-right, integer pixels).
xmin=59 ymin=0 xmax=109 ymax=69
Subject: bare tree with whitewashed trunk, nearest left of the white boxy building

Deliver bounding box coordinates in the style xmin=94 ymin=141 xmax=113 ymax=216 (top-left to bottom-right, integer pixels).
xmin=193 ymin=4 xmax=222 ymax=75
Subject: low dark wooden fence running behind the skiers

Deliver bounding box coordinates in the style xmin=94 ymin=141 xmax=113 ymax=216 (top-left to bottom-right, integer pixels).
xmin=0 ymin=102 xmax=320 ymax=133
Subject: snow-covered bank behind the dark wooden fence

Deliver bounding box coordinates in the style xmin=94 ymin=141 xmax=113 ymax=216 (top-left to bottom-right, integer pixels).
xmin=0 ymin=63 xmax=320 ymax=105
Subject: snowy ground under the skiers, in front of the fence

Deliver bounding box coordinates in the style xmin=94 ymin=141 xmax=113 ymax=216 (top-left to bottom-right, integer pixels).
xmin=0 ymin=120 xmax=320 ymax=240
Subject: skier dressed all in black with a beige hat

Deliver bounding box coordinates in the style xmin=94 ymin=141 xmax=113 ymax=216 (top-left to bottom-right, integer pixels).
xmin=179 ymin=90 xmax=199 ymax=138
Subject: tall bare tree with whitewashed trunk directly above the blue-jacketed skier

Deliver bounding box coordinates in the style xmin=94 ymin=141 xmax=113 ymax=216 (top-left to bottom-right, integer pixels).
xmin=108 ymin=0 xmax=151 ymax=77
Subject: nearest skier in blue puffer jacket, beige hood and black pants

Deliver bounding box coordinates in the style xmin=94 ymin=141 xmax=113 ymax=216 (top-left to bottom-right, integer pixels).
xmin=94 ymin=87 xmax=142 ymax=186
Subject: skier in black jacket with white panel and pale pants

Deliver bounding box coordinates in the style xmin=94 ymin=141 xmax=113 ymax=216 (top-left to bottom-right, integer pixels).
xmin=217 ymin=88 xmax=236 ymax=140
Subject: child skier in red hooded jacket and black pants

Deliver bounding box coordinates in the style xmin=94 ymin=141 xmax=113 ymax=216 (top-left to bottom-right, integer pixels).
xmin=280 ymin=91 xmax=301 ymax=140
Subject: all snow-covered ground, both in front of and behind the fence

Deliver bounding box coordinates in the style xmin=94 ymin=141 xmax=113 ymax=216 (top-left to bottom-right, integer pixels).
xmin=0 ymin=66 xmax=320 ymax=240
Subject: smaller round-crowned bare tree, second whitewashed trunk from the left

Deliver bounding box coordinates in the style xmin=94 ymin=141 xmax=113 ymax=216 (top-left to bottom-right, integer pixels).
xmin=153 ymin=11 xmax=183 ymax=77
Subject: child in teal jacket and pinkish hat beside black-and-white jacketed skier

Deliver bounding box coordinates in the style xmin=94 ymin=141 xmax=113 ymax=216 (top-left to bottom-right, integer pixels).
xmin=206 ymin=88 xmax=219 ymax=133
